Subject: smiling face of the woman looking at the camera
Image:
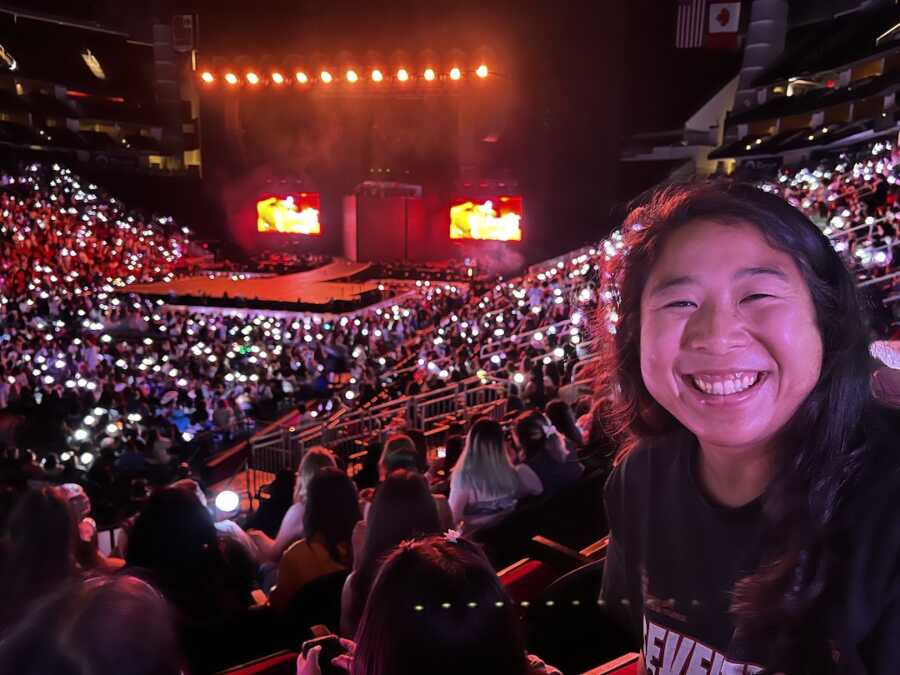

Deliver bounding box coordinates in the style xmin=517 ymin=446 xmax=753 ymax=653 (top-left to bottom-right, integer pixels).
xmin=641 ymin=221 xmax=822 ymax=453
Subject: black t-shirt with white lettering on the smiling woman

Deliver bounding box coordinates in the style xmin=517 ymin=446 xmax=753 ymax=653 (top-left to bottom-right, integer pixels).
xmin=603 ymin=428 xmax=900 ymax=675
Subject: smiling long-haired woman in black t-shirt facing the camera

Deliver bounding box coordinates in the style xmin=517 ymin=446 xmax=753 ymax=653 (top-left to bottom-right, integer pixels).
xmin=597 ymin=183 xmax=900 ymax=675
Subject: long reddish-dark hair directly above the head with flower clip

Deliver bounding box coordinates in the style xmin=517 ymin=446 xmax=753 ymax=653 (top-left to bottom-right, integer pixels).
xmin=349 ymin=469 xmax=441 ymax=626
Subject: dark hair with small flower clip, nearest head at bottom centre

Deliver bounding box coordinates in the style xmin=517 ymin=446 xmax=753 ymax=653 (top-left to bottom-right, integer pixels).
xmin=352 ymin=536 xmax=528 ymax=675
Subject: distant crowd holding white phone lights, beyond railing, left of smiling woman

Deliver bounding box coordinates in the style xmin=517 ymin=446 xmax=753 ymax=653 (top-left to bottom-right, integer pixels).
xmin=0 ymin=165 xmax=594 ymax=523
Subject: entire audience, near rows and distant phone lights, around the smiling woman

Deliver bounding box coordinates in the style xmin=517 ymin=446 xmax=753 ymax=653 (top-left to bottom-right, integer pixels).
xmin=0 ymin=139 xmax=900 ymax=675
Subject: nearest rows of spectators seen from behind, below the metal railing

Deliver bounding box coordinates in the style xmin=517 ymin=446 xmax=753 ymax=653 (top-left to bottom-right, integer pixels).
xmin=0 ymin=390 xmax=607 ymax=673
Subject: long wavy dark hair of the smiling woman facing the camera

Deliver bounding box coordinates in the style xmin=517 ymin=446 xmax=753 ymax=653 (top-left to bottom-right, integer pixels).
xmin=597 ymin=183 xmax=888 ymax=673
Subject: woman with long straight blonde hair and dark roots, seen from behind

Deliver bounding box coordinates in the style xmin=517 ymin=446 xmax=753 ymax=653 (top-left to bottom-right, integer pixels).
xmin=450 ymin=419 xmax=544 ymax=532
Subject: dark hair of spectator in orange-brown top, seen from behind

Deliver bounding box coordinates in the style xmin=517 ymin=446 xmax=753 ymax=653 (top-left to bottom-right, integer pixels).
xmin=303 ymin=467 xmax=362 ymax=565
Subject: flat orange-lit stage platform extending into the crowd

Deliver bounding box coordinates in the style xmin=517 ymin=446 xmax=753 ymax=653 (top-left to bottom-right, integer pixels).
xmin=122 ymin=260 xmax=378 ymax=305
